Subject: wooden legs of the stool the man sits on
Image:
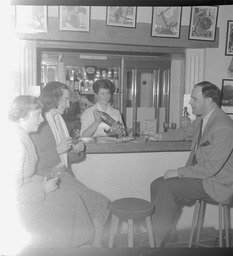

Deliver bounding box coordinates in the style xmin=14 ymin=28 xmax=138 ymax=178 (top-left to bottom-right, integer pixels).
xmin=188 ymin=200 xmax=230 ymax=247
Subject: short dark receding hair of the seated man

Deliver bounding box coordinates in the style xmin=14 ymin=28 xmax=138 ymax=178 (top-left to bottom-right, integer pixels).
xmin=195 ymin=81 xmax=221 ymax=106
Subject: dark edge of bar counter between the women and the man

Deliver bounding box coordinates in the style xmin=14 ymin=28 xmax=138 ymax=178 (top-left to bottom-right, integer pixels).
xmin=86 ymin=141 xmax=191 ymax=154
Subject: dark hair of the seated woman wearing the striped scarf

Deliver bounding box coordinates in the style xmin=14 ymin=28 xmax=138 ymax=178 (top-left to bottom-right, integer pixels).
xmin=39 ymin=81 xmax=69 ymax=112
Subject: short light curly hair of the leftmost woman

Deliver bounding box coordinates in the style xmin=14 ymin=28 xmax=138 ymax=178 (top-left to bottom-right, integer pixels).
xmin=9 ymin=95 xmax=43 ymax=122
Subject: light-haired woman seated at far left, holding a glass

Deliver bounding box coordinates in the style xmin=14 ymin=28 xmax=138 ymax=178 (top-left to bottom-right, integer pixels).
xmin=9 ymin=95 xmax=104 ymax=248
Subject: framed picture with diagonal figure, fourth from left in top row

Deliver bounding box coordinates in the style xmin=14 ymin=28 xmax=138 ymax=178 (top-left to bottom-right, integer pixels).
xmin=151 ymin=6 xmax=182 ymax=38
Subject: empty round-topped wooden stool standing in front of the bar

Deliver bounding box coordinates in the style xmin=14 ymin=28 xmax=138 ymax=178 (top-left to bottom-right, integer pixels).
xmin=108 ymin=198 xmax=155 ymax=247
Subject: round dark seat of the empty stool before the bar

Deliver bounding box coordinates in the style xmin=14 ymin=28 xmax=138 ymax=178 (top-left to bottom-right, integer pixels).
xmin=110 ymin=197 xmax=154 ymax=219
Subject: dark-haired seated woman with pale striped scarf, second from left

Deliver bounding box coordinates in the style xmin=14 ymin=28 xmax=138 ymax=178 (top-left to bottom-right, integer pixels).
xmin=31 ymin=82 xmax=109 ymax=247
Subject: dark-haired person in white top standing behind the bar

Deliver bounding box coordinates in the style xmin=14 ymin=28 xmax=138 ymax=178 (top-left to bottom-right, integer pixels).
xmin=80 ymin=79 xmax=124 ymax=137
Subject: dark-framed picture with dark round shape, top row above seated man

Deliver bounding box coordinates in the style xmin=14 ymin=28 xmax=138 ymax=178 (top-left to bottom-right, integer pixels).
xmin=189 ymin=6 xmax=218 ymax=41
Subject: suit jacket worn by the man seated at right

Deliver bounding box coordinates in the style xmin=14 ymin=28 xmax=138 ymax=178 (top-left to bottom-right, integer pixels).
xmin=162 ymin=108 xmax=233 ymax=203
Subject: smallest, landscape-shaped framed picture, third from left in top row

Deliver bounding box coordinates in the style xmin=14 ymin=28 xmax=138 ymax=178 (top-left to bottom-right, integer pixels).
xmin=106 ymin=6 xmax=137 ymax=28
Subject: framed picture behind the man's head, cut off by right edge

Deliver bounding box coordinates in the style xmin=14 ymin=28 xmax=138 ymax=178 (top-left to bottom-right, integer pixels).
xmin=221 ymin=79 xmax=233 ymax=114
